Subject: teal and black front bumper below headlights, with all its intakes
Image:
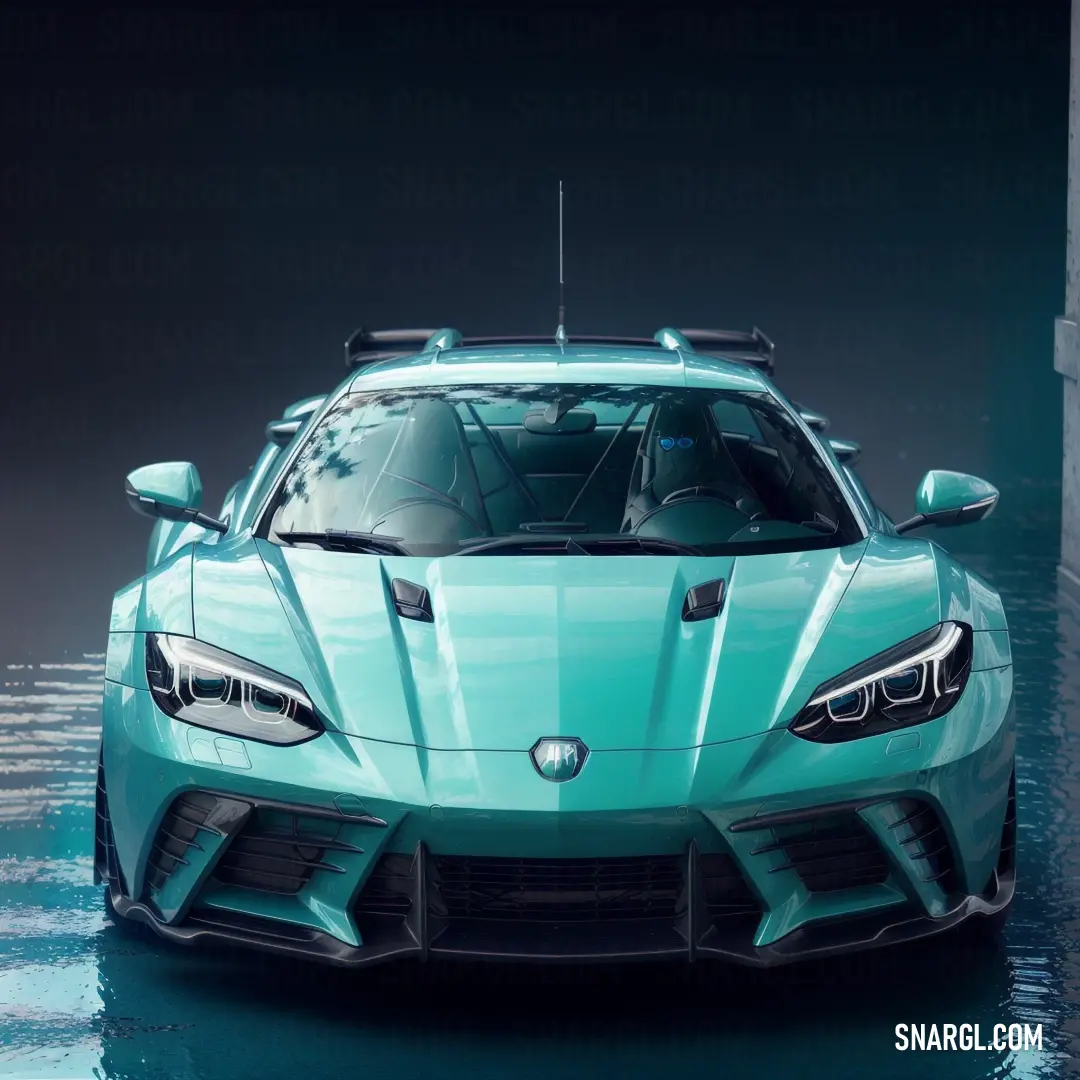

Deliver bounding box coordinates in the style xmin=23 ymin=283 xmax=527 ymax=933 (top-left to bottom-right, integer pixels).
xmin=95 ymin=669 xmax=1015 ymax=967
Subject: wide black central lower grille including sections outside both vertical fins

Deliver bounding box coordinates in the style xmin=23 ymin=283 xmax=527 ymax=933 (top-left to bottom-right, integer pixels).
xmin=353 ymin=843 xmax=761 ymax=960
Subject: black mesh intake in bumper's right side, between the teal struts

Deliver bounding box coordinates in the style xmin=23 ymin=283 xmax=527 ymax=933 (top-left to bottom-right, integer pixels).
xmin=758 ymin=812 xmax=889 ymax=892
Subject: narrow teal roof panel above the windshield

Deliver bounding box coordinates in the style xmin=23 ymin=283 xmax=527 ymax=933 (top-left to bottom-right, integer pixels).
xmin=347 ymin=343 xmax=773 ymax=393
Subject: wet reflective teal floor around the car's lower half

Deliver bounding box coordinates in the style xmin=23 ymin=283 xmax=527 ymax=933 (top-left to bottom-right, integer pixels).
xmin=0 ymin=509 xmax=1080 ymax=1080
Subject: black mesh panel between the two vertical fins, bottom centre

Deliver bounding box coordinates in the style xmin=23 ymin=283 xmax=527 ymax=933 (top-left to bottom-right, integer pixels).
xmin=433 ymin=855 xmax=686 ymax=922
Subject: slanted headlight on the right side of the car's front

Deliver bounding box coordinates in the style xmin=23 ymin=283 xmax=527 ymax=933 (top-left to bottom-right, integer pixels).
xmin=789 ymin=622 xmax=972 ymax=743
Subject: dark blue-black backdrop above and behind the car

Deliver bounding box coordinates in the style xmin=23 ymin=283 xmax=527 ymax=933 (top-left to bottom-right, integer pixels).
xmin=0 ymin=0 xmax=1069 ymax=659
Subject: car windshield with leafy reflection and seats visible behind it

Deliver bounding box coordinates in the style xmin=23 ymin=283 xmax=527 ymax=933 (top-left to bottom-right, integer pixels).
xmin=256 ymin=383 xmax=862 ymax=557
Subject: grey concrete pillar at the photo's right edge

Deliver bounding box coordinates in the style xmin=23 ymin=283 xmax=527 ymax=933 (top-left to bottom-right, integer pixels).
xmin=1054 ymin=0 xmax=1080 ymax=600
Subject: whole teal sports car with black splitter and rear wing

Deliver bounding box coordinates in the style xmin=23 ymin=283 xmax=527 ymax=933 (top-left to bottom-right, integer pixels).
xmin=94 ymin=327 xmax=1016 ymax=966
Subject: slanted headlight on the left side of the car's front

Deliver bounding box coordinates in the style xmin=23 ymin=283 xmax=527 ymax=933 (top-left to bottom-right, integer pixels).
xmin=146 ymin=634 xmax=323 ymax=746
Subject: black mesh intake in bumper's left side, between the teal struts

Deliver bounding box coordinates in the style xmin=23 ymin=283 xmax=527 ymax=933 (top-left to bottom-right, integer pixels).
xmin=214 ymin=809 xmax=360 ymax=895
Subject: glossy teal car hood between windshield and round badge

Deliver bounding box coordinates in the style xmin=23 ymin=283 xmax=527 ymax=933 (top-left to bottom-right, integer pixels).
xmin=192 ymin=538 xmax=940 ymax=751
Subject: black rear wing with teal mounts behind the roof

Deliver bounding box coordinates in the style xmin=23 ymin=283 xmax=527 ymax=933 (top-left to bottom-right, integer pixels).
xmin=345 ymin=326 xmax=775 ymax=376
